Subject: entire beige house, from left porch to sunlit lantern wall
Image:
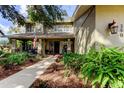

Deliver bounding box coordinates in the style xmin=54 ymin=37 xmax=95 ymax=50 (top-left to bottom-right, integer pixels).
xmin=8 ymin=5 xmax=124 ymax=55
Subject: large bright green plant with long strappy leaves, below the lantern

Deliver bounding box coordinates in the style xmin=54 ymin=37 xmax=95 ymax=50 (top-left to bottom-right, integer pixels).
xmin=81 ymin=48 xmax=124 ymax=88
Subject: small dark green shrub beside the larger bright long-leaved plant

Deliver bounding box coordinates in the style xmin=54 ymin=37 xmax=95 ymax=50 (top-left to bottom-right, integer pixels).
xmin=63 ymin=53 xmax=84 ymax=72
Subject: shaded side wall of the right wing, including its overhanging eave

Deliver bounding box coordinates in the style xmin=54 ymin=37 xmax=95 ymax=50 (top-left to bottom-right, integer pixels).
xmin=73 ymin=6 xmax=95 ymax=53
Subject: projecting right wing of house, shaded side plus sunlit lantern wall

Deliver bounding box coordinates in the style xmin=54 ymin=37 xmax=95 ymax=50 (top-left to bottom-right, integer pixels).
xmin=73 ymin=5 xmax=124 ymax=53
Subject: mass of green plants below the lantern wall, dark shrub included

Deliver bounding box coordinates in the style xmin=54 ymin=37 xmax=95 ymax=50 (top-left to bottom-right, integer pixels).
xmin=64 ymin=47 xmax=124 ymax=88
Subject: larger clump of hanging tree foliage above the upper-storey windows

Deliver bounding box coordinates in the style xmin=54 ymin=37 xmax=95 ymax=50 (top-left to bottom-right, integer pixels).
xmin=28 ymin=5 xmax=67 ymax=27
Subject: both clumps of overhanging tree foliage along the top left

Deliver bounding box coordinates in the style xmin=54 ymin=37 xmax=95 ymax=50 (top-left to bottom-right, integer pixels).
xmin=0 ymin=5 xmax=67 ymax=27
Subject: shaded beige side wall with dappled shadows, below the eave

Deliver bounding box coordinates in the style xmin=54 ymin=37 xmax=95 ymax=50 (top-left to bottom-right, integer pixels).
xmin=74 ymin=7 xmax=95 ymax=53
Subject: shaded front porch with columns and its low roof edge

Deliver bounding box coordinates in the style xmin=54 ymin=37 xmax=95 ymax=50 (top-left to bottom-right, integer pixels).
xmin=9 ymin=33 xmax=74 ymax=56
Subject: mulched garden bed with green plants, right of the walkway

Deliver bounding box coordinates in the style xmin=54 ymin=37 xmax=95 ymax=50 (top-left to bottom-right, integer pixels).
xmin=32 ymin=47 xmax=124 ymax=88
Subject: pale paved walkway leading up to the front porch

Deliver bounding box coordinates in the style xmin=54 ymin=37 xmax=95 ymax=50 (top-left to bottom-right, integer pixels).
xmin=0 ymin=56 xmax=55 ymax=88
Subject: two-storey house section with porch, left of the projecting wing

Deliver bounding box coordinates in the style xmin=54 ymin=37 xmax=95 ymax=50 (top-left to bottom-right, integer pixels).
xmin=8 ymin=18 xmax=74 ymax=55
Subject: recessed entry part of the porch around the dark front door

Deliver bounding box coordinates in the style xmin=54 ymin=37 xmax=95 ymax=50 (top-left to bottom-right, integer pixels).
xmin=45 ymin=39 xmax=74 ymax=54
